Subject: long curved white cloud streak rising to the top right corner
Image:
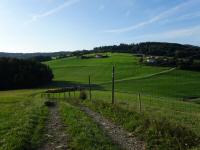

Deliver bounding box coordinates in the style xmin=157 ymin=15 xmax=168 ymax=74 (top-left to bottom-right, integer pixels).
xmin=104 ymin=0 xmax=197 ymax=33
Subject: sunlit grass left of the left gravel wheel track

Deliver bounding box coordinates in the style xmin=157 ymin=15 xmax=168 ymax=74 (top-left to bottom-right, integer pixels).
xmin=0 ymin=90 xmax=48 ymax=150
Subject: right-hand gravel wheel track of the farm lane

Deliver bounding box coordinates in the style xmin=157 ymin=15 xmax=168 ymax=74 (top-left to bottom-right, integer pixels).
xmin=80 ymin=106 xmax=145 ymax=150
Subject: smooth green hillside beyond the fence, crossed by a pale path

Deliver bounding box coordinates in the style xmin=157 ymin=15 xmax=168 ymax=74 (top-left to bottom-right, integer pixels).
xmin=47 ymin=54 xmax=200 ymax=99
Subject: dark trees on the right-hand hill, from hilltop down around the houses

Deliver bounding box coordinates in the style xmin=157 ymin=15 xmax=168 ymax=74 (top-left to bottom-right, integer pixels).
xmin=72 ymin=42 xmax=200 ymax=71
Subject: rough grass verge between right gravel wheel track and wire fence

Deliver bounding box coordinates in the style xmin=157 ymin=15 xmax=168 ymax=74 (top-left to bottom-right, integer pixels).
xmin=84 ymin=101 xmax=200 ymax=150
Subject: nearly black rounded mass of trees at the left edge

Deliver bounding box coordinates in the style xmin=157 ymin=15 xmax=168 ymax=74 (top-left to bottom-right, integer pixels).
xmin=0 ymin=58 xmax=53 ymax=90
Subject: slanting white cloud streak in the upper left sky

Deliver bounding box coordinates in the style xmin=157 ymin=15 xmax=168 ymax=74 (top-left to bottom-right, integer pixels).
xmin=25 ymin=0 xmax=80 ymax=24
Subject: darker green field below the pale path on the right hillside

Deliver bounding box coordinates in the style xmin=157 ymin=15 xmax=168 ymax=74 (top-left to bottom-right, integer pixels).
xmin=110 ymin=70 xmax=200 ymax=98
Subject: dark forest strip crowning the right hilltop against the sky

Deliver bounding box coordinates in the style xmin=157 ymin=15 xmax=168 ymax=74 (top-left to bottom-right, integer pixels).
xmin=93 ymin=42 xmax=200 ymax=59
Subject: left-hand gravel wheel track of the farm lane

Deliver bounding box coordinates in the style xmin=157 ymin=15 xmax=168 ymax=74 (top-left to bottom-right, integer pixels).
xmin=39 ymin=104 xmax=67 ymax=150
